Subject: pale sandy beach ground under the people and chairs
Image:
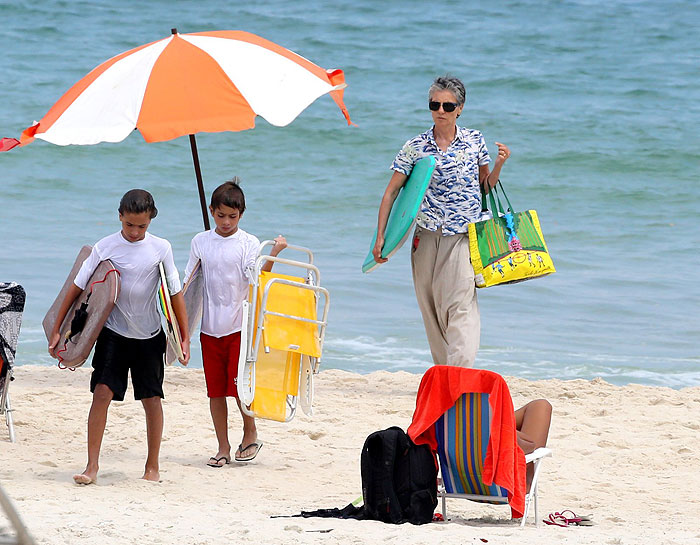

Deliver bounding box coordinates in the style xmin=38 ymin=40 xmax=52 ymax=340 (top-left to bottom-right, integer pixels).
xmin=0 ymin=366 xmax=700 ymax=545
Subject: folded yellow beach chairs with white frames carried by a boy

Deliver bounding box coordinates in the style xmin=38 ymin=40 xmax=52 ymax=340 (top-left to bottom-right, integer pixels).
xmin=238 ymin=240 xmax=330 ymax=422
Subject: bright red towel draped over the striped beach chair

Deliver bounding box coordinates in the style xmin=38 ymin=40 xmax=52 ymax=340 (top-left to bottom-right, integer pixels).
xmin=408 ymin=365 xmax=526 ymax=518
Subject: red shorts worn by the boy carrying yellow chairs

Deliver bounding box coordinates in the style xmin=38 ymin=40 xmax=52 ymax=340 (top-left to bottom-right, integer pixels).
xmin=199 ymin=331 xmax=241 ymax=397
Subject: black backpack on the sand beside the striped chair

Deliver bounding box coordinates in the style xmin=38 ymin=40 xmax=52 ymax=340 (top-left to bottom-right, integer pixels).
xmin=360 ymin=426 xmax=437 ymax=524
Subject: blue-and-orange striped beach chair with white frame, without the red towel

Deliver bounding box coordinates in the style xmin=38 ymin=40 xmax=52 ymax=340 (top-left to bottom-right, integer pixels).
xmin=435 ymin=393 xmax=551 ymax=526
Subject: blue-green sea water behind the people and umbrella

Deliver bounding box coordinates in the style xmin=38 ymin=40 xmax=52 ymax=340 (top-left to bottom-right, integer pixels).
xmin=0 ymin=0 xmax=700 ymax=388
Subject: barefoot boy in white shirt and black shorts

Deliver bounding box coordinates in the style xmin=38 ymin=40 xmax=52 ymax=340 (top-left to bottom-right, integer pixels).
xmin=49 ymin=189 xmax=190 ymax=484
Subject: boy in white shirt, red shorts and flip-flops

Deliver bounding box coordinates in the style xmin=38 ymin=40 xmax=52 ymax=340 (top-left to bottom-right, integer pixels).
xmin=185 ymin=176 xmax=287 ymax=467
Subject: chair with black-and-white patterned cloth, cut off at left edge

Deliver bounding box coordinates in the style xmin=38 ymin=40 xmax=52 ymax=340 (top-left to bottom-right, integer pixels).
xmin=0 ymin=282 xmax=26 ymax=443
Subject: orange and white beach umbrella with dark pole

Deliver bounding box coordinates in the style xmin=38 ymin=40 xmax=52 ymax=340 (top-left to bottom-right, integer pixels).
xmin=0 ymin=29 xmax=351 ymax=229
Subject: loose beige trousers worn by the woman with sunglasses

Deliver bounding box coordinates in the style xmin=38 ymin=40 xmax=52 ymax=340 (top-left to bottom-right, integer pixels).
xmin=411 ymin=227 xmax=481 ymax=367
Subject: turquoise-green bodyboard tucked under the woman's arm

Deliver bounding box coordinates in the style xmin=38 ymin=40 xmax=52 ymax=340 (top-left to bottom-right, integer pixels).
xmin=362 ymin=156 xmax=435 ymax=272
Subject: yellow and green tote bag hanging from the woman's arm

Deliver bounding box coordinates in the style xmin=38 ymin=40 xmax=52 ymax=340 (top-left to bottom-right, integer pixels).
xmin=469 ymin=181 xmax=555 ymax=288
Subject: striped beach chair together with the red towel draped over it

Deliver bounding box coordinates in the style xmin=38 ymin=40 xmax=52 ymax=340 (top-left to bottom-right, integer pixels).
xmin=409 ymin=365 xmax=551 ymax=526
